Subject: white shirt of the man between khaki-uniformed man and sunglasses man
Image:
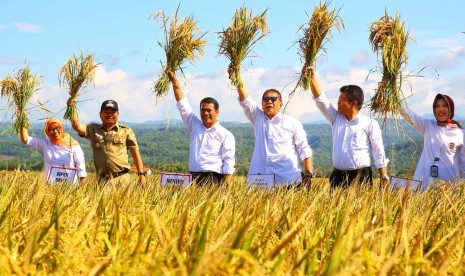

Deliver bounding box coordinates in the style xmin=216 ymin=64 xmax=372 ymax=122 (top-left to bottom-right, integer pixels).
xmin=176 ymin=97 xmax=236 ymax=174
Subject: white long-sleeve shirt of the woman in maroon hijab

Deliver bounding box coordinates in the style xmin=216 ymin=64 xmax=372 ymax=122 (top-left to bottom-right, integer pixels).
xmin=400 ymin=105 xmax=465 ymax=189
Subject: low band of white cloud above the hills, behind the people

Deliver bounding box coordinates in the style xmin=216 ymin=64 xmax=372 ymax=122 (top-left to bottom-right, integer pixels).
xmin=4 ymin=65 xmax=465 ymax=126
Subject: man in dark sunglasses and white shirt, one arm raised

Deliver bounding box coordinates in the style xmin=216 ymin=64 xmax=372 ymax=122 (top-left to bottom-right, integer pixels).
xmin=230 ymin=68 xmax=313 ymax=187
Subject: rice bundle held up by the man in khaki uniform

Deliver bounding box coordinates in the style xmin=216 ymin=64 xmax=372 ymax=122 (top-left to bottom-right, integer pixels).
xmin=58 ymin=53 xmax=100 ymax=120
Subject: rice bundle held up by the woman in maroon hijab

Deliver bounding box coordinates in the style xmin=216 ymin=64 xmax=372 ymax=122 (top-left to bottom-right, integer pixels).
xmin=370 ymin=12 xmax=413 ymax=120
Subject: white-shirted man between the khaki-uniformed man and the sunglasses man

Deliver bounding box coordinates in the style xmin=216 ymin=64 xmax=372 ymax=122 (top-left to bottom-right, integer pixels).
xmin=167 ymin=71 xmax=236 ymax=185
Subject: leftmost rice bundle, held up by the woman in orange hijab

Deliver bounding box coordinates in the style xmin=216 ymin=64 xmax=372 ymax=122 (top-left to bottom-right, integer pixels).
xmin=0 ymin=66 xmax=40 ymax=134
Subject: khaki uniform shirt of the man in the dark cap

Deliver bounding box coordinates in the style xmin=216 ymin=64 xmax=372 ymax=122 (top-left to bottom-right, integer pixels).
xmin=84 ymin=124 xmax=139 ymax=175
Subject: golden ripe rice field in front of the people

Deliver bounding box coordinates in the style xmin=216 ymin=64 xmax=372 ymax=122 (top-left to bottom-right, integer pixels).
xmin=0 ymin=171 xmax=465 ymax=275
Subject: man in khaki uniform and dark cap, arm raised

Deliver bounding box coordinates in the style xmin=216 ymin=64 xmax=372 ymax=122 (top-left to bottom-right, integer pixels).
xmin=68 ymin=98 xmax=146 ymax=185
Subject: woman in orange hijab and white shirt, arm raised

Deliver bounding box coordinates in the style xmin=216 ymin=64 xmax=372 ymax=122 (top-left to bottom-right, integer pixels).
xmin=20 ymin=118 xmax=87 ymax=183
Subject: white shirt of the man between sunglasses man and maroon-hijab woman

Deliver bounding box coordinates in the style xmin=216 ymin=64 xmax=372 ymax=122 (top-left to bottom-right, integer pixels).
xmin=314 ymin=93 xmax=389 ymax=170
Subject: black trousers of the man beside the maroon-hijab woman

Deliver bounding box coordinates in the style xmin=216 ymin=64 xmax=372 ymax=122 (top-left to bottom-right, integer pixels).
xmin=329 ymin=167 xmax=373 ymax=188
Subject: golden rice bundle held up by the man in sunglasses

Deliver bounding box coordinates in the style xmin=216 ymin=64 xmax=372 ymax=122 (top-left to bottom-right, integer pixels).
xmin=218 ymin=7 xmax=268 ymax=86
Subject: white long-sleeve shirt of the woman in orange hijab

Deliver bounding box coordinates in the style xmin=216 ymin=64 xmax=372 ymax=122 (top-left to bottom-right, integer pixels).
xmin=26 ymin=136 xmax=87 ymax=183
